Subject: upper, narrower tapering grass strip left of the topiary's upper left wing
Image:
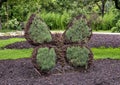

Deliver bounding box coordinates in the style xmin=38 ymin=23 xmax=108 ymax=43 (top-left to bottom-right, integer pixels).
xmin=0 ymin=38 xmax=25 ymax=48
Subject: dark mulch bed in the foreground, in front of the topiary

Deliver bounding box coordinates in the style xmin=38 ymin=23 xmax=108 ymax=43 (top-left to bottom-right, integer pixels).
xmin=0 ymin=59 xmax=120 ymax=85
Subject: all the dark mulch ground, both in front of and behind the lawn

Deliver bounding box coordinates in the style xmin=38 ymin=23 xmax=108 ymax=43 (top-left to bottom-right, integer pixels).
xmin=0 ymin=34 xmax=120 ymax=85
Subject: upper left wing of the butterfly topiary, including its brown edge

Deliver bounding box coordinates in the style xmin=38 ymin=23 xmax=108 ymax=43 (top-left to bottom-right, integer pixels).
xmin=25 ymin=15 xmax=52 ymax=44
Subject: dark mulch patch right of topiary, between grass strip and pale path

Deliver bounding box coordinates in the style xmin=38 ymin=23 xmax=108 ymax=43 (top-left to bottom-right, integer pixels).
xmin=88 ymin=34 xmax=120 ymax=47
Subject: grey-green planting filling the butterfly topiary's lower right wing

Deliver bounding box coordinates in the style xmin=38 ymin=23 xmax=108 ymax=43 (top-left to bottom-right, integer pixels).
xmin=66 ymin=46 xmax=90 ymax=67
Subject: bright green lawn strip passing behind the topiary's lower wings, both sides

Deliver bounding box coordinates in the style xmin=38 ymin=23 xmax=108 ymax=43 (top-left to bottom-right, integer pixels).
xmin=0 ymin=48 xmax=120 ymax=60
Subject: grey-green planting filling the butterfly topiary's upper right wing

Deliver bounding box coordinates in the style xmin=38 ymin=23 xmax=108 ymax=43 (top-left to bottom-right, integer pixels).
xmin=65 ymin=18 xmax=91 ymax=42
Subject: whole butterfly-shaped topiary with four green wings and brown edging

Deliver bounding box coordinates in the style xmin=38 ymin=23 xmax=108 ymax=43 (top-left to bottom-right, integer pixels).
xmin=25 ymin=14 xmax=93 ymax=73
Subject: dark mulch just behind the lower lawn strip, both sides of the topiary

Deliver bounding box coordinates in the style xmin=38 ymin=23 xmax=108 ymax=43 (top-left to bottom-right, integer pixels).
xmin=4 ymin=34 xmax=120 ymax=49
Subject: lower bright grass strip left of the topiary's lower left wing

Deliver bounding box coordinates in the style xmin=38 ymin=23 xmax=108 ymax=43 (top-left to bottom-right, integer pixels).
xmin=0 ymin=49 xmax=33 ymax=60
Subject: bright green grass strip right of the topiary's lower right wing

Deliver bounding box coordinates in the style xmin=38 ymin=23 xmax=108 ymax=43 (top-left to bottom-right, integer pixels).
xmin=92 ymin=48 xmax=120 ymax=60
